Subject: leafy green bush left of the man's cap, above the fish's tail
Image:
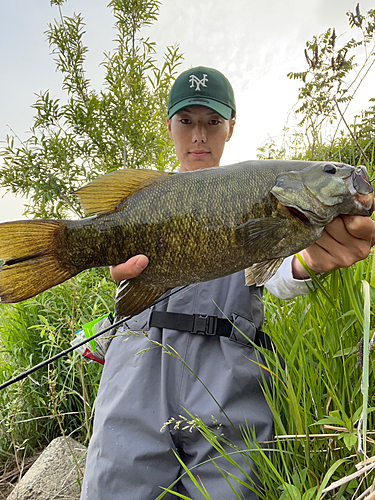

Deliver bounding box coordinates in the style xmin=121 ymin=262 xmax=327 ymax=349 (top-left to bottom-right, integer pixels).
xmin=0 ymin=0 xmax=182 ymax=218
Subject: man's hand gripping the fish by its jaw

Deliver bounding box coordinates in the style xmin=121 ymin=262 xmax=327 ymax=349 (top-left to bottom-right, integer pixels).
xmin=292 ymin=215 xmax=375 ymax=279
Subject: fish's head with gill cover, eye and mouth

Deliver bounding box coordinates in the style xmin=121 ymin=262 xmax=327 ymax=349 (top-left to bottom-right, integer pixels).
xmin=271 ymin=162 xmax=374 ymax=227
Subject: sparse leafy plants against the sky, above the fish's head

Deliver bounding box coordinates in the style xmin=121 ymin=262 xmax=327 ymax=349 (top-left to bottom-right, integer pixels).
xmin=258 ymin=4 xmax=375 ymax=165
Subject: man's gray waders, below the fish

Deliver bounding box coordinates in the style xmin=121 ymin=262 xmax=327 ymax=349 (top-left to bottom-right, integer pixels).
xmin=81 ymin=272 xmax=273 ymax=500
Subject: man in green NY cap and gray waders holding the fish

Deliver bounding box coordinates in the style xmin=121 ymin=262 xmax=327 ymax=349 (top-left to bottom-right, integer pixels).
xmin=81 ymin=67 xmax=374 ymax=500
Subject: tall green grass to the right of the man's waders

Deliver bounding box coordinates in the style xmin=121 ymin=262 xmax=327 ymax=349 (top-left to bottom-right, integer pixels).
xmin=250 ymin=256 xmax=375 ymax=499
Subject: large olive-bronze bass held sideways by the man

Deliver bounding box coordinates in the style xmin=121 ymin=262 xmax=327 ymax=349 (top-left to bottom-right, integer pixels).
xmin=0 ymin=160 xmax=374 ymax=317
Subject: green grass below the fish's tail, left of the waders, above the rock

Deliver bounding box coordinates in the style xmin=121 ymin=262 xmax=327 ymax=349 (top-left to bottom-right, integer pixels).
xmin=0 ymin=269 xmax=115 ymax=462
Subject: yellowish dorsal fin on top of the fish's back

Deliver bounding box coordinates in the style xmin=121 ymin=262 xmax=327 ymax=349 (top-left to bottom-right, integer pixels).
xmin=74 ymin=168 xmax=171 ymax=215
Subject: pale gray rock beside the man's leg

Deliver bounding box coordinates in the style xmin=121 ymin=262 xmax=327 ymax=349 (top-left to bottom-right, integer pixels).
xmin=7 ymin=437 xmax=86 ymax=500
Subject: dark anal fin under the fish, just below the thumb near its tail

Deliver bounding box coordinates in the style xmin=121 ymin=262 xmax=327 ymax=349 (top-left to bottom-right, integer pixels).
xmin=116 ymin=278 xmax=168 ymax=318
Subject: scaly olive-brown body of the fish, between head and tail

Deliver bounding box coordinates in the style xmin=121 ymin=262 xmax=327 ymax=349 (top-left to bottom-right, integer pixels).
xmin=62 ymin=162 xmax=294 ymax=286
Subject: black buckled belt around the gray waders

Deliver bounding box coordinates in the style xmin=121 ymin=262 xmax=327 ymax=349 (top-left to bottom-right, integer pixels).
xmin=149 ymin=311 xmax=274 ymax=350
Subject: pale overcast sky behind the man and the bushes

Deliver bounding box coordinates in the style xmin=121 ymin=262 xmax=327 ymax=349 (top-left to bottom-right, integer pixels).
xmin=0 ymin=0 xmax=375 ymax=221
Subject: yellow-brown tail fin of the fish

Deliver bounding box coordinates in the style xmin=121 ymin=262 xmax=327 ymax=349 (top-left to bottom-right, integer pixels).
xmin=0 ymin=220 xmax=77 ymax=303
